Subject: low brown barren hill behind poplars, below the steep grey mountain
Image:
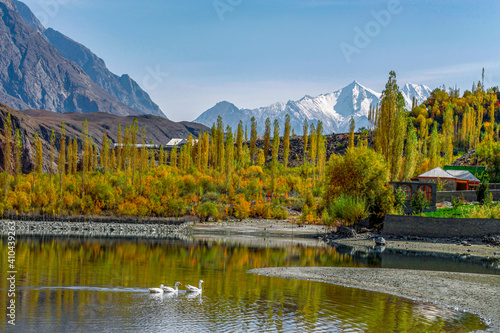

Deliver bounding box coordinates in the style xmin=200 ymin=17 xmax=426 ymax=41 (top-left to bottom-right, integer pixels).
xmin=0 ymin=102 xmax=209 ymax=172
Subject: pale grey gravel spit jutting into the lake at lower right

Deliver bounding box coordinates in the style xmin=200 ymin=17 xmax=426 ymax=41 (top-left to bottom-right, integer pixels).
xmin=248 ymin=267 xmax=500 ymax=332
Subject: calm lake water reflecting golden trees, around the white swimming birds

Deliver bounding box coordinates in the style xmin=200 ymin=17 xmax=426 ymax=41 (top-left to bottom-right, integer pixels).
xmin=0 ymin=238 xmax=492 ymax=332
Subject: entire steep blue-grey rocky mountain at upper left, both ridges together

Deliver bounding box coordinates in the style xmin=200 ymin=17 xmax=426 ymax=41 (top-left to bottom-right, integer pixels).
xmin=0 ymin=0 xmax=164 ymax=117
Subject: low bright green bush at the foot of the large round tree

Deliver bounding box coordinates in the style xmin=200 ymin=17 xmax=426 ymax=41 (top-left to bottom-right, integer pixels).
xmin=325 ymin=194 xmax=369 ymax=226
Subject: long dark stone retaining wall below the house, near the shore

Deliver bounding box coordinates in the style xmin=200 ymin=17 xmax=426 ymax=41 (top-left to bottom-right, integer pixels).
xmin=382 ymin=215 xmax=500 ymax=238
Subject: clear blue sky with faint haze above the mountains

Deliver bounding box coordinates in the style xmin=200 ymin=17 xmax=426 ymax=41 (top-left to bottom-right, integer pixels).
xmin=19 ymin=0 xmax=500 ymax=121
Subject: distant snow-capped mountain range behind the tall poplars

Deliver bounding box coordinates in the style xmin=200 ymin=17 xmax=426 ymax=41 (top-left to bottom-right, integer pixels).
xmin=195 ymin=81 xmax=430 ymax=135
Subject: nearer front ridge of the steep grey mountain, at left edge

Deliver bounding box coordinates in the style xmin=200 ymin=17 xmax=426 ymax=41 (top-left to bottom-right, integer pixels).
xmin=0 ymin=0 xmax=138 ymax=115
